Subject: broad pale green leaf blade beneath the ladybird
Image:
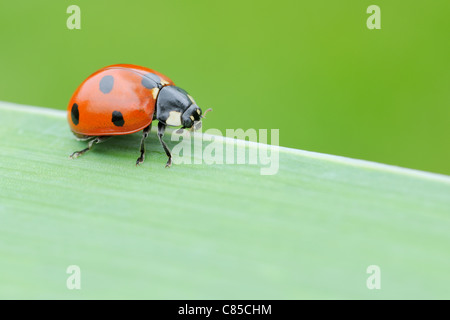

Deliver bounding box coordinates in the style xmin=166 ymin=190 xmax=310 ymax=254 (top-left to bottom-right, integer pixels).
xmin=0 ymin=103 xmax=450 ymax=299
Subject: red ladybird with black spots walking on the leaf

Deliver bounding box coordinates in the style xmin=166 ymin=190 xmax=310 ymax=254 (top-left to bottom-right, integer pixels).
xmin=67 ymin=64 xmax=210 ymax=167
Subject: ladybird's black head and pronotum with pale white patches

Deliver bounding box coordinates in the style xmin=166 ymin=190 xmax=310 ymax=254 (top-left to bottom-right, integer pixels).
xmin=156 ymin=86 xmax=209 ymax=129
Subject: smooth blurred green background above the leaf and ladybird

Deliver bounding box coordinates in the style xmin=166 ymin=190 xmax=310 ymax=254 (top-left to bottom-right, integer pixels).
xmin=0 ymin=0 xmax=450 ymax=174
